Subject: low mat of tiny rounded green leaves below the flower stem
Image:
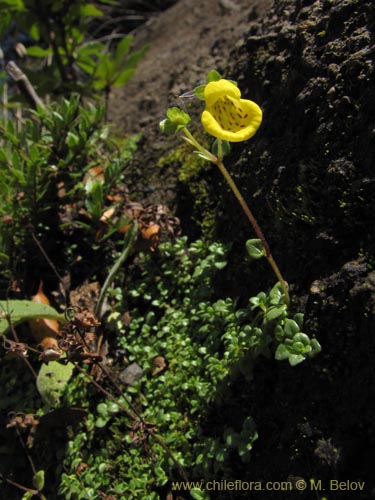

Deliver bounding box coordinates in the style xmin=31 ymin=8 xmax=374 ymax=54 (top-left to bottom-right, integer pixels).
xmin=60 ymin=238 xmax=320 ymax=499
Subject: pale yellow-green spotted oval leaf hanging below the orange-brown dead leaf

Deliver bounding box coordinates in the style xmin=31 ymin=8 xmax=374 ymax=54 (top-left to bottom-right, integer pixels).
xmin=36 ymin=361 xmax=74 ymax=406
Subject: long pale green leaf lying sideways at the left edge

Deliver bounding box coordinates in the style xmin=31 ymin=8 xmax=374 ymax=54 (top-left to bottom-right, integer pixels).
xmin=0 ymin=300 xmax=65 ymax=333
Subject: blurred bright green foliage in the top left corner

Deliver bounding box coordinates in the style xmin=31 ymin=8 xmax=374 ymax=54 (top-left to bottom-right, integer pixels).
xmin=0 ymin=0 xmax=147 ymax=100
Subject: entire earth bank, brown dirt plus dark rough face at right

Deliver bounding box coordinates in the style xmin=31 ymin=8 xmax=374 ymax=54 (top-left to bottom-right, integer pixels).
xmin=111 ymin=0 xmax=375 ymax=500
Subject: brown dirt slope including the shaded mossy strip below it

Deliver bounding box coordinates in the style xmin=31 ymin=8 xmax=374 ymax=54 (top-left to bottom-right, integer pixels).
xmin=109 ymin=0 xmax=272 ymax=208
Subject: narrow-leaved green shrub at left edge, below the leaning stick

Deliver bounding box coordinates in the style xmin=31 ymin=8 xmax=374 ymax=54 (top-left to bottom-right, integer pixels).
xmin=0 ymin=95 xmax=137 ymax=290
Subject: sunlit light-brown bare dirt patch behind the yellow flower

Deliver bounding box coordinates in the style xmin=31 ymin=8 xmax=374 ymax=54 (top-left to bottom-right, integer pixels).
xmin=109 ymin=0 xmax=271 ymax=133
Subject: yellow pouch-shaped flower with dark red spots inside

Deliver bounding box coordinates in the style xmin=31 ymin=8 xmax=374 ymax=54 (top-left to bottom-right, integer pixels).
xmin=201 ymin=79 xmax=262 ymax=142
